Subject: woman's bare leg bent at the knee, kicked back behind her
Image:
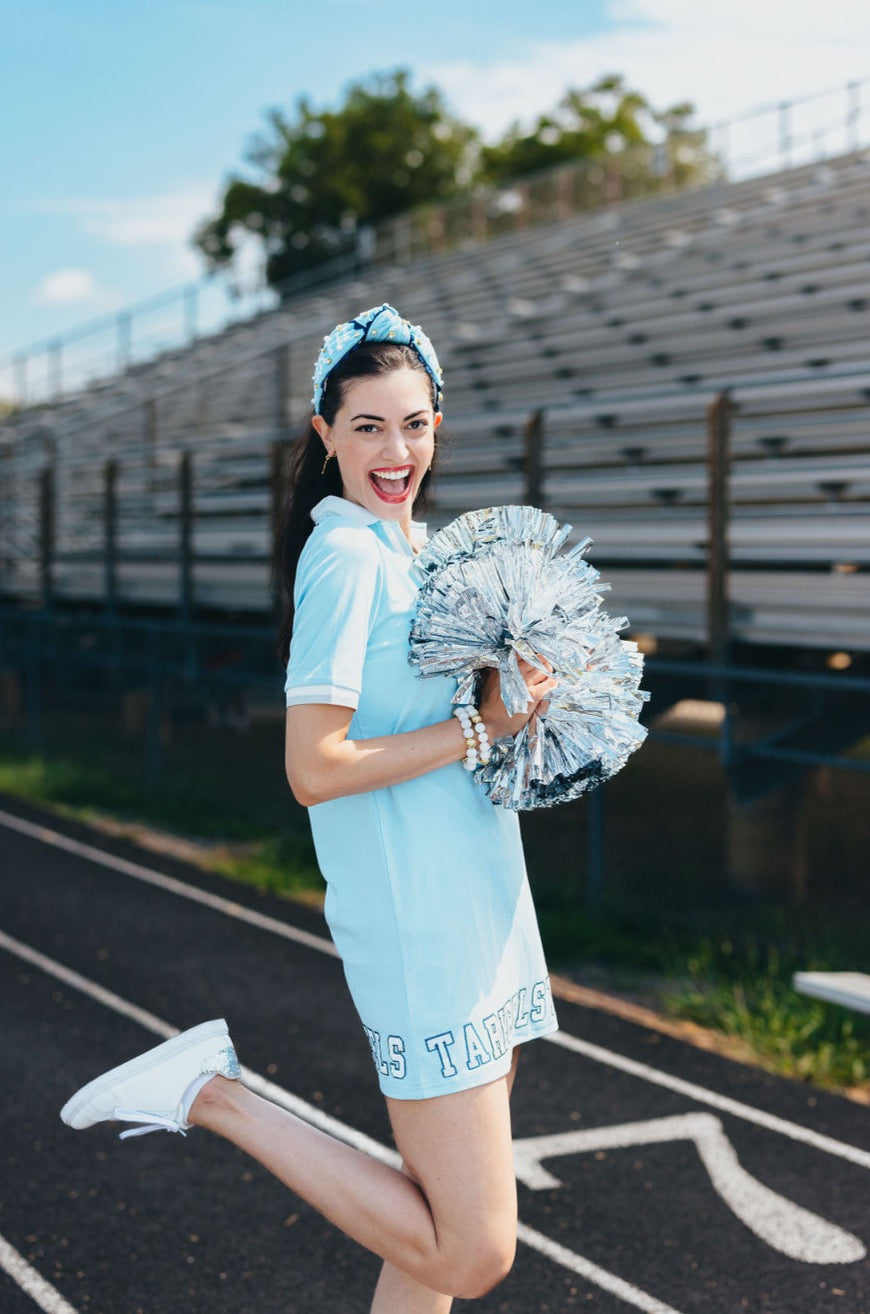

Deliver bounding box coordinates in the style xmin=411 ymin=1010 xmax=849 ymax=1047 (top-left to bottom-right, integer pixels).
xmin=189 ymin=1061 xmax=516 ymax=1298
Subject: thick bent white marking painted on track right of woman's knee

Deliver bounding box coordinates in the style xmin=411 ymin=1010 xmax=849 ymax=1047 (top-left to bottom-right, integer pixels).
xmin=514 ymin=1113 xmax=866 ymax=1264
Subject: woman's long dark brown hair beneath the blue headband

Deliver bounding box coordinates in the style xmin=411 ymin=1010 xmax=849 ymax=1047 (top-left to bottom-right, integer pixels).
xmin=273 ymin=342 xmax=435 ymax=665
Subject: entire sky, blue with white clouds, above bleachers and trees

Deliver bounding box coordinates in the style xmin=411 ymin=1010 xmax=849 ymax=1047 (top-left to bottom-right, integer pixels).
xmin=0 ymin=0 xmax=870 ymax=381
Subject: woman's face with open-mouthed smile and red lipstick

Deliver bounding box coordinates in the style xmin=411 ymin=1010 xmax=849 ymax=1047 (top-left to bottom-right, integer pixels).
xmin=313 ymin=368 xmax=442 ymax=533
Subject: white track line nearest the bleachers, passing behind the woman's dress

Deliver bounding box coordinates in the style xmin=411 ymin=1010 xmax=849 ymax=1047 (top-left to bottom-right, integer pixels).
xmin=0 ymin=808 xmax=870 ymax=1168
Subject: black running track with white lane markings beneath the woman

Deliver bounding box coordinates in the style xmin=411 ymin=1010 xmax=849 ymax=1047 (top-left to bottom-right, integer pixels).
xmin=0 ymin=798 xmax=870 ymax=1314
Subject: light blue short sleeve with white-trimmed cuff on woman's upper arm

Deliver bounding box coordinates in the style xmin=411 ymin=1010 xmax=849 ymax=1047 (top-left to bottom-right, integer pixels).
xmin=284 ymin=526 xmax=378 ymax=708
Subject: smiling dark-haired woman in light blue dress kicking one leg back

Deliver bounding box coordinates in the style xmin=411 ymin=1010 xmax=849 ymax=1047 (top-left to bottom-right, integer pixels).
xmin=62 ymin=306 xmax=556 ymax=1314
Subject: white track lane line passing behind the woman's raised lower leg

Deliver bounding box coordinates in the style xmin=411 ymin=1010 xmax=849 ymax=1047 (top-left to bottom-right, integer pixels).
xmin=0 ymin=930 xmax=679 ymax=1314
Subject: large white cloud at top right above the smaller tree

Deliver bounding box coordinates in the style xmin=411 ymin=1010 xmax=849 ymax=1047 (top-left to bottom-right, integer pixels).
xmin=430 ymin=0 xmax=870 ymax=169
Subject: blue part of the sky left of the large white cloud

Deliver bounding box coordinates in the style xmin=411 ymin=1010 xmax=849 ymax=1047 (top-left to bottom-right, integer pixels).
xmin=0 ymin=0 xmax=620 ymax=356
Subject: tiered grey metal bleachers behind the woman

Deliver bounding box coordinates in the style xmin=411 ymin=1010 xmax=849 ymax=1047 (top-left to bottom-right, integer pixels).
xmin=0 ymin=152 xmax=870 ymax=650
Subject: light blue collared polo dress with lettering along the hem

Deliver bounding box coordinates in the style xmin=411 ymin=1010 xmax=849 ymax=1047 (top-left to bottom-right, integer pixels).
xmin=285 ymin=497 xmax=557 ymax=1100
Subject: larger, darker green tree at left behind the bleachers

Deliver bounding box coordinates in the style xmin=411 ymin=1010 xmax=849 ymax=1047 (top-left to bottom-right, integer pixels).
xmin=193 ymin=70 xmax=477 ymax=286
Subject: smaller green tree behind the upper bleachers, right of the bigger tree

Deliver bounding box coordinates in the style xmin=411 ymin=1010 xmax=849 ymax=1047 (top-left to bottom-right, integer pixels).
xmin=480 ymin=75 xmax=715 ymax=187
